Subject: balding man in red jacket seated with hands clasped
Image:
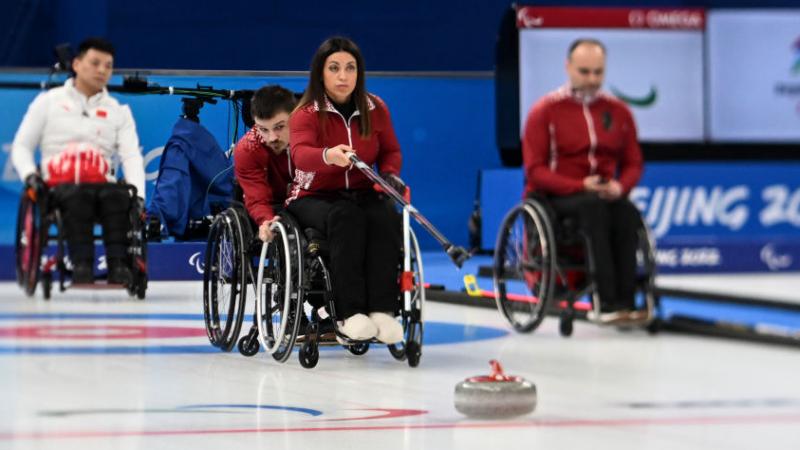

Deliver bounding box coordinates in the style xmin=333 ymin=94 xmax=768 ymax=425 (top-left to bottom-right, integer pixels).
xmin=522 ymin=39 xmax=645 ymax=322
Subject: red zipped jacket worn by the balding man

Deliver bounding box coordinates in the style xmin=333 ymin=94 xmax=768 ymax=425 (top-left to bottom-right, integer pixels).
xmin=522 ymin=85 xmax=643 ymax=195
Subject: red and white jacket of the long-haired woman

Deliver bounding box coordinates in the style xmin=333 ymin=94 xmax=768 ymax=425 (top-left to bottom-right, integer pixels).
xmin=287 ymin=95 xmax=403 ymax=203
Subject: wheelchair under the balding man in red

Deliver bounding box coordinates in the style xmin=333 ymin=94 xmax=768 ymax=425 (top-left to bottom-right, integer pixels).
xmin=492 ymin=196 xmax=659 ymax=337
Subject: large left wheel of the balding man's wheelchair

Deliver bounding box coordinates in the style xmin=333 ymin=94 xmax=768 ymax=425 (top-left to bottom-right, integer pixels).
xmin=493 ymin=201 xmax=555 ymax=333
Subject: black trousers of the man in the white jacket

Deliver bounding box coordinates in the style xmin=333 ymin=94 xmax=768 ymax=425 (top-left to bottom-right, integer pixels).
xmin=53 ymin=183 xmax=131 ymax=262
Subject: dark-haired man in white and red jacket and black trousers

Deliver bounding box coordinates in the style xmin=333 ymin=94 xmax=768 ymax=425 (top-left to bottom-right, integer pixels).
xmin=11 ymin=38 xmax=145 ymax=285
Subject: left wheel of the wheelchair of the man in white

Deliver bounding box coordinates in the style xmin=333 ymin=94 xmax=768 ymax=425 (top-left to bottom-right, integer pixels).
xmin=15 ymin=188 xmax=47 ymax=297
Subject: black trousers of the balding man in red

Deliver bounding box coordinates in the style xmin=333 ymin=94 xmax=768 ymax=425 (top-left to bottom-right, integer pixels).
xmin=550 ymin=193 xmax=640 ymax=310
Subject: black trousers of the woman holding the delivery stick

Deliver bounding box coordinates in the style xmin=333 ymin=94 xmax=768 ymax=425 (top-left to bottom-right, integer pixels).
xmin=287 ymin=191 xmax=402 ymax=319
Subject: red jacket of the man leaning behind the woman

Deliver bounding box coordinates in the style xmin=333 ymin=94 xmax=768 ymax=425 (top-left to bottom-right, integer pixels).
xmin=233 ymin=129 xmax=292 ymax=225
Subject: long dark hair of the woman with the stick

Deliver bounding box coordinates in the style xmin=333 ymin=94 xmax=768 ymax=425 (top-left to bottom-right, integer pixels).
xmin=299 ymin=36 xmax=372 ymax=137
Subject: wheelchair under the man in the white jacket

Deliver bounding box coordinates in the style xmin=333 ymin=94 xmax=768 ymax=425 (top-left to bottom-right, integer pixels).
xmin=15 ymin=182 xmax=148 ymax=300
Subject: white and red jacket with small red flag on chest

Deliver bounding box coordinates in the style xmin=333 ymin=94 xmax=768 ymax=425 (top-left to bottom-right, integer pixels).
xmin=11 ymin=79 xmax=145 ymax=198
